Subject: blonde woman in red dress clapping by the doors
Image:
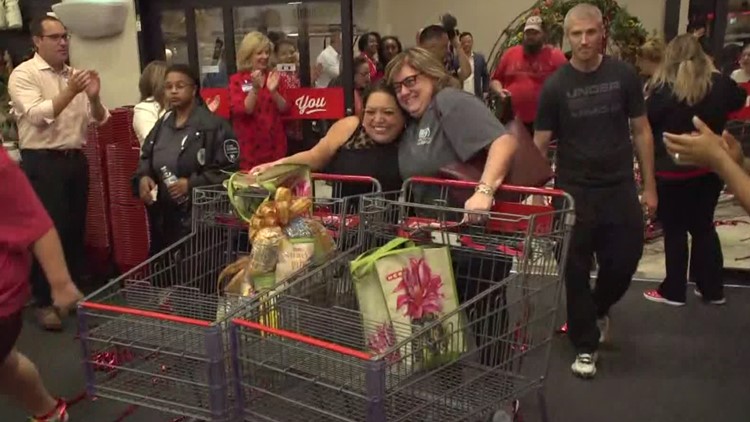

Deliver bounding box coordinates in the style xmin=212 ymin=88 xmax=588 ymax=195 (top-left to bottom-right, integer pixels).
xmin=229 ymin=32 xmax=288 ymax=170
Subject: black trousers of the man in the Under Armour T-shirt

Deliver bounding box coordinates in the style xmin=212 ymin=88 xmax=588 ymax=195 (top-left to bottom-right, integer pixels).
xmin=558 ymin=183 xmax=643 ymax=353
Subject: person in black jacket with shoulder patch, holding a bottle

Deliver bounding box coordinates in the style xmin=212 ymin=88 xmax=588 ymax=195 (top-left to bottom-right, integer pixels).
xmin=133 ymin=64 xmax=240 ymax=256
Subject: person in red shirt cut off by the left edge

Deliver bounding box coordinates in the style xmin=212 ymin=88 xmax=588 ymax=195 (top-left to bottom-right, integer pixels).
xmin=0 ymin=148 xmax=81 ymax=422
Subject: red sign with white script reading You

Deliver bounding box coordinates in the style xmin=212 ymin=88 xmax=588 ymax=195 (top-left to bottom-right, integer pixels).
xmin=286 ymin=88 xmax=346 ymax=120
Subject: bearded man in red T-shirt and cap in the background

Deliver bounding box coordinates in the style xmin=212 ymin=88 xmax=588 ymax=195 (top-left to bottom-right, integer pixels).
xmin=490 ymin=16 xmax=568 ymax=134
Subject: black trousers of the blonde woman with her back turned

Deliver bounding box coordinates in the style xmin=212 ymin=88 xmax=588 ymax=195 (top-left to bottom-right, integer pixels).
xmin=657 ymin=174 xmax=724 ymax=302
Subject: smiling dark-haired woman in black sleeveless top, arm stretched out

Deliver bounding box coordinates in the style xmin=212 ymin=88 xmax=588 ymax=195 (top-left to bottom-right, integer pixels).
xmin=251 ymin=83 xmax=405 ymax=197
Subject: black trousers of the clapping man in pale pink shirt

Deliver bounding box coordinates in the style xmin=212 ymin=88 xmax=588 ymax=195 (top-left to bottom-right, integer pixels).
xmin=21 ymin=150 xmax=89 ymax=307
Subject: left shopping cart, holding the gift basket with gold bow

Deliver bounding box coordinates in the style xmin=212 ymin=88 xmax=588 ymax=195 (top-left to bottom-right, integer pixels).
xmin=78 ymin=175 xmax=380 ymax=421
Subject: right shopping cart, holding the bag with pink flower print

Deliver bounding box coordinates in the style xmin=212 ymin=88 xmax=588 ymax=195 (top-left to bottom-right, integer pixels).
xmin=231 ymin=178 xmax=574 ymax=422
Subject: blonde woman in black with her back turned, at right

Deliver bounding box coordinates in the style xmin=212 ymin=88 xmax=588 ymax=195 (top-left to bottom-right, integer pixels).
xmin=644 ymin=34 xmax=746 ymax=306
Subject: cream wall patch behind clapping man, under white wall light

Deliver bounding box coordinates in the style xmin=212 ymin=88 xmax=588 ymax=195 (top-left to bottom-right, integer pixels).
xmin=70 ymin=1 xmax=141 ymax=108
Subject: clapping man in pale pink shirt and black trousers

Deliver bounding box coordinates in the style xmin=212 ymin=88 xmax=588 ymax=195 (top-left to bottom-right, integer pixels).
xmin=8 ymin=16 xmax=109 ymax=331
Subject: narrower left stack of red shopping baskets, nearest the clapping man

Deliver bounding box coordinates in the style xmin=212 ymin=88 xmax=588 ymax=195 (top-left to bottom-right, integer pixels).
xmin=83 ymin=120 xmax=112 ymax=275
